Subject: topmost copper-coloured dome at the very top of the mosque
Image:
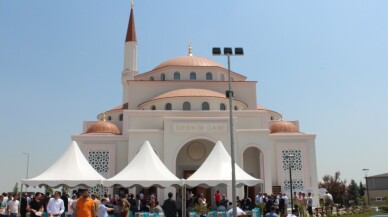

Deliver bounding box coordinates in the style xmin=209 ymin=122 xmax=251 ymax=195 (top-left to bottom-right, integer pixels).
xmin=153 ymin=56 xmax=223 ymax=70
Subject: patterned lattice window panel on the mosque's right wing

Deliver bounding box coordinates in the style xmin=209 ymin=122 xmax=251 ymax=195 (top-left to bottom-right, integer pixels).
xmin=282 ymin=149 xmax=304 ymax=191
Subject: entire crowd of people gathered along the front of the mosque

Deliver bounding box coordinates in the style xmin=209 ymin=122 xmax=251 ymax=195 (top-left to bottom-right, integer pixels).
xmin=0 ymin=189 xmax=332 ymax=217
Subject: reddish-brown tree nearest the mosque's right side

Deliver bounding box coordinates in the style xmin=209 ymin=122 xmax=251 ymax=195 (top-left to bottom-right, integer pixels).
xmin=318 ymin=171 xmax=346 ymax=204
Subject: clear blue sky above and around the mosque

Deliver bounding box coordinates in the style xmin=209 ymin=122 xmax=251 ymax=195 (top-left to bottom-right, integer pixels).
xmin=0 ymin=0 xmax=388 ymax=191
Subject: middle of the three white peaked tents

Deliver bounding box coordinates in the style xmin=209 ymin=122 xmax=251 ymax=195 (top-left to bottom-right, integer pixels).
xmin=103 ymin=141 xmax=182 ymax=188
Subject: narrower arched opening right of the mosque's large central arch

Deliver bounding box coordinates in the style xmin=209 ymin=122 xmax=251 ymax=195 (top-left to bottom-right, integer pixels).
xmin=243 ymin=147 xmax=264 ymax=199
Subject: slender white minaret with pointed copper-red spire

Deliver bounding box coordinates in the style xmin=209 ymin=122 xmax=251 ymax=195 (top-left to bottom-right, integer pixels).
xmin=121 ymin=0 xmax=138 ymax=85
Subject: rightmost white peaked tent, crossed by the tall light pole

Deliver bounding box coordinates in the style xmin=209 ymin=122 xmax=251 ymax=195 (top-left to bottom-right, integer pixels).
xmin=185 ymin=141 xmax=263 ymax=187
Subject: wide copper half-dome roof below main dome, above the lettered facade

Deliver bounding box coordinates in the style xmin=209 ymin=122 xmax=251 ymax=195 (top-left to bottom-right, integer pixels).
xmin=152 ymin=88 xmax=226 ymax=100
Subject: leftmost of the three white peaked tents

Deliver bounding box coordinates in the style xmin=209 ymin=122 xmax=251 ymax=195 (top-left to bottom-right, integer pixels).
xmin=22 ymin=141 xmax=105 ymax=188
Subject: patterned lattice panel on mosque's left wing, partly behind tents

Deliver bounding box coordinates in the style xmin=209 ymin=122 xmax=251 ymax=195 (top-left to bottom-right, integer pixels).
xmin=88 ymin=150 xmax=109 ymax=196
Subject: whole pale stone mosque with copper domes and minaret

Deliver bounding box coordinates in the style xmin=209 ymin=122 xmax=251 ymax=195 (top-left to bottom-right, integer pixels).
xmin=72 ymin=4 xmax=318 ymax=204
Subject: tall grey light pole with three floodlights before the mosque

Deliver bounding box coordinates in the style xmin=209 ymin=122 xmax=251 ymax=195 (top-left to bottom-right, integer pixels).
xmin=213 ymin=47 xmax=244 ymax=217
